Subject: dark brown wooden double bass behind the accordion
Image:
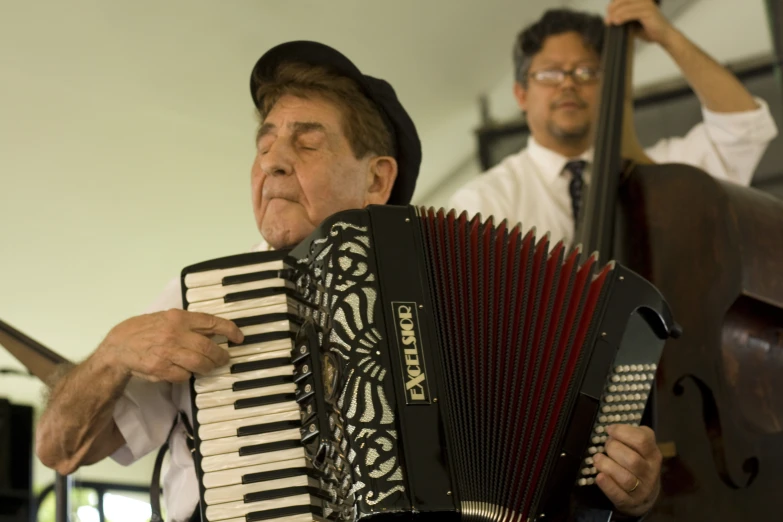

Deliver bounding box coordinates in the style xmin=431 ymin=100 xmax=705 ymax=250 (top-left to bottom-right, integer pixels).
xmin=577 ymin=8 xmax=783 ymax=522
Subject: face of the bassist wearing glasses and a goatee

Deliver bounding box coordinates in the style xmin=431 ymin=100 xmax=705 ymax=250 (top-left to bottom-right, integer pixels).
xmin=515 ymin=32 xmax=600 ymax=143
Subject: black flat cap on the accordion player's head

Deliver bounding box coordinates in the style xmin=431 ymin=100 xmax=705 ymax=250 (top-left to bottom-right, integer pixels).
xmin=250 ymin=41 xmax=421 ymax=205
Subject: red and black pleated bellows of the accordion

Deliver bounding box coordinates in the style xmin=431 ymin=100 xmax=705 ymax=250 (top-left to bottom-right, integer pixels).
xmin=420 ymin=209 xmax=614 ymax=520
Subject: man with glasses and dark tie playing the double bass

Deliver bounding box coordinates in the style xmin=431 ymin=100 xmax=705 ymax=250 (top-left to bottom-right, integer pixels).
xmin=450 ymin=0 xmax=777 ymax=248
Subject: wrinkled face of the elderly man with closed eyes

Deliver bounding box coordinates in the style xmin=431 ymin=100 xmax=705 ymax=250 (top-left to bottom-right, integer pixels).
xmin=251 ymin=95 xmax=372 ymax=249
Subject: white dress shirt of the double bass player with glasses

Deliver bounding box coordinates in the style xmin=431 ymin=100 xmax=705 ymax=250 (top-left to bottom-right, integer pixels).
xmin=449 ymin=98 xmax=778 ymax=245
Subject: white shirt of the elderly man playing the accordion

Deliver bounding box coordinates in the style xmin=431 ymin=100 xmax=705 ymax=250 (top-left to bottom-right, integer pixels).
xmin=111 ymin=240 xmax=272 ymax=522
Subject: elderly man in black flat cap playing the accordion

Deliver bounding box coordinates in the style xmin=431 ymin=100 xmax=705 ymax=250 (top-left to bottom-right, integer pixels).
xmin=37 ymin=42 xmax=661 ymax=521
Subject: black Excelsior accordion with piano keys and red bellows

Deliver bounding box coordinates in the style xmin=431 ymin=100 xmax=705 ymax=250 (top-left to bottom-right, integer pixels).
xmin=182 ymin=206 xmax=677 ymax=522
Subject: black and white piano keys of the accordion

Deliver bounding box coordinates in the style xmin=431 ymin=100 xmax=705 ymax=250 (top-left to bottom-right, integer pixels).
xmin=185 ymin=261 xmax=320 ymax=522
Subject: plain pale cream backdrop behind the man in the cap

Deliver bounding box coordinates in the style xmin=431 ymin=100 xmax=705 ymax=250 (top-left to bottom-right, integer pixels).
xmin=0 ymin=0 xmax=552 ymax=356
